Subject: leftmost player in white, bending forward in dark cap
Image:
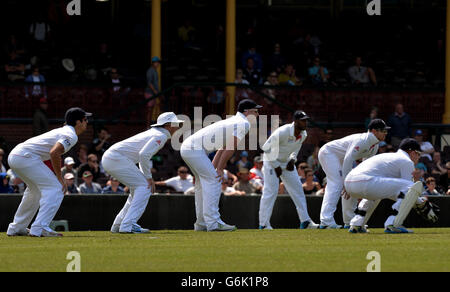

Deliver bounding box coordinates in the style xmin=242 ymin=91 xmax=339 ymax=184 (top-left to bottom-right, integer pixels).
xmin=6 ymin=108 xmax=92 ymax=237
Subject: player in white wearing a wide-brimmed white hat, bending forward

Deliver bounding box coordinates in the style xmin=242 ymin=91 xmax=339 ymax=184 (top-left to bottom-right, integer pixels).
xmin=102 ymin=112 xmax=183 ymax=233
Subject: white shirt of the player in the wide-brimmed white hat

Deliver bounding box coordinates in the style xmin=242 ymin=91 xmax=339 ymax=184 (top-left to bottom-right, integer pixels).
xmin=107 ymin=127 xmax=171 ymax=179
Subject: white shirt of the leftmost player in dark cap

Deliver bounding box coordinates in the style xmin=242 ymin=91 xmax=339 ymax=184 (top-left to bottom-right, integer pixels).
xmin=13 ymin=125 xmax=78 ymax=161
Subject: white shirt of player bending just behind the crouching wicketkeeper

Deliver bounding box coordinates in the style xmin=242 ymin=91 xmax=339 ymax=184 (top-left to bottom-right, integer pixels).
xmin=322 ymin=131 xmax=380 ymax=178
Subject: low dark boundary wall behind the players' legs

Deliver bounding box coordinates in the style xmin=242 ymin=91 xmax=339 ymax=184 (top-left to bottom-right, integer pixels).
xmin=0 ymin=194 xmax=450 ymax=232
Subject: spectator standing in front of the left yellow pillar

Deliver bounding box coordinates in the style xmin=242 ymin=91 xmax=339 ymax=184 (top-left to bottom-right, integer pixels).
xmin=145 ymin=56 xmax=161 ymax=125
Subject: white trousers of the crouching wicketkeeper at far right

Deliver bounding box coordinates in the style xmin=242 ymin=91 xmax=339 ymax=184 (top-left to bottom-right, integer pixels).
xmin=345 ymin=176 xmax=414 ymax=227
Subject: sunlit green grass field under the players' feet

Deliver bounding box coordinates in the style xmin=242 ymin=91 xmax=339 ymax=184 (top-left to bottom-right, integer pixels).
xmin=0 ymin=228 xmax=450 ymax=272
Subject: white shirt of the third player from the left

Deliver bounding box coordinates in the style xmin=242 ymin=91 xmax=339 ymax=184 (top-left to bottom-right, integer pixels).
xmin=181 ymin=112 xmax=250 ymax=154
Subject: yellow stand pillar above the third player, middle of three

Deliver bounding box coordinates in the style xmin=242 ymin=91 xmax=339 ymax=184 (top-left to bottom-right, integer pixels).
xmin=225 ymin=0 xmax=236 ymax=115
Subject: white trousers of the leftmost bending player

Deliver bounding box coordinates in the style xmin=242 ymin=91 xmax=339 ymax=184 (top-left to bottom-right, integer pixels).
xmin=7 ymin=149 xmax=64 ymax=236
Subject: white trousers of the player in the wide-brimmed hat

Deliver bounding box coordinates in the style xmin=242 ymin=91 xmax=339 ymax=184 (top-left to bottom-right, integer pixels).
xmin=102 ymin=151 xmax=152 ymax=232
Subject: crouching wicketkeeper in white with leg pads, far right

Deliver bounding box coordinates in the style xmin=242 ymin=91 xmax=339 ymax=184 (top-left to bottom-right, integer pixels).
xmin=345 ymin=138 xmax=425 ymax=233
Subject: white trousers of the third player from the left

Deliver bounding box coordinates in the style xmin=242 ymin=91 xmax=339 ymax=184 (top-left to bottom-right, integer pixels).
xmin=180 ymin=146 xmax=224 ymax=230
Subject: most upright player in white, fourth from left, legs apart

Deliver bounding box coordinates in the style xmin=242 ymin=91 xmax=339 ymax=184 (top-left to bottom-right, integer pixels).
xmin=259 ymin=111 xmax=319 ymax=230
